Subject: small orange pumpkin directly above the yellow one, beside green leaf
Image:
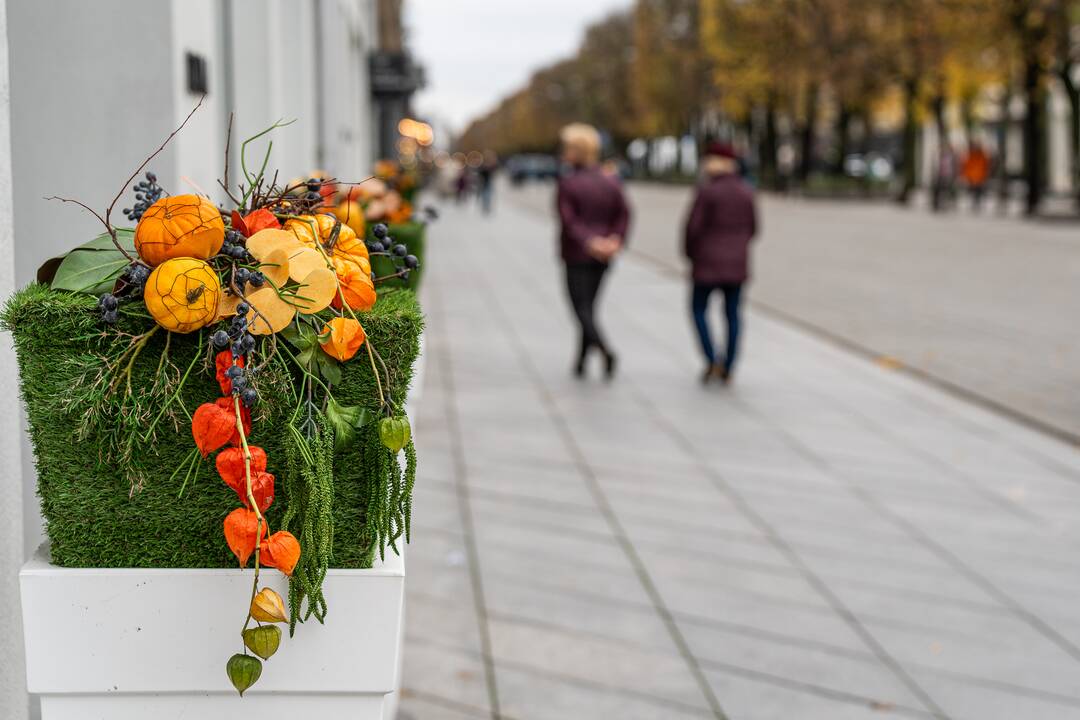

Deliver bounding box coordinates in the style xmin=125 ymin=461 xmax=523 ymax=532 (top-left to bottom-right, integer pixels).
xmin=135 ymin=195 xmax=225 ymax=267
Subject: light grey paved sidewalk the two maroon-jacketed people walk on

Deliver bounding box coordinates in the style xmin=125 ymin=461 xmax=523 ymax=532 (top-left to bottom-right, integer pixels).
xmin=400 ymin=197 xmax=1080 ymax=720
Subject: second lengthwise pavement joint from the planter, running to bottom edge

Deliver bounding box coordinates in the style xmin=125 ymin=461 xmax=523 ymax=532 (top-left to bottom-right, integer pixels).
xmin=468 ymin=254 xmax=728 ymax=720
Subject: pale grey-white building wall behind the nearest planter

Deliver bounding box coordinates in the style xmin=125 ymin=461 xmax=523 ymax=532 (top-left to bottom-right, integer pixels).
xmin=0 ymin=0 xmax=376 ymax=720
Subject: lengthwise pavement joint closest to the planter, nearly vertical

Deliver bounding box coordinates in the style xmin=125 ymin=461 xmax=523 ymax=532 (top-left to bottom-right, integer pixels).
xmin=427 ymin=278 xmax=503 ymax=720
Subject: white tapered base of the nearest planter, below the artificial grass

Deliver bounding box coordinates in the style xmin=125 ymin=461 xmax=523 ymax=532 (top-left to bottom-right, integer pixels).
xmin=19 ymin=546 xmax=405 ymax=720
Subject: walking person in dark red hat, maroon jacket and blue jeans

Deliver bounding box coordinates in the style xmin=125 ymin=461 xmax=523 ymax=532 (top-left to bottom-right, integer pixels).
xmin=686 ymin=142 xmax=757 ymax=384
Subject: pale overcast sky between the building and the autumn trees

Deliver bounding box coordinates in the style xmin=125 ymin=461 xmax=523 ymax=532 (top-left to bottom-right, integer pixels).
xmin=405 ymin=0 xmax=631 ymax=131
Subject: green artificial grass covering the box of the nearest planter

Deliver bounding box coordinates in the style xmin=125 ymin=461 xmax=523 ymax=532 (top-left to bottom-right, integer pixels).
xmin=0 ymin=284 xmax=422 ymax=568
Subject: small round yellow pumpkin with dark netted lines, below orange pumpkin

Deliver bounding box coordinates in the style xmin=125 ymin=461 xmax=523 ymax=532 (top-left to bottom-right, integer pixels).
xmin=143 ymin=258 xmax=221 ymax=332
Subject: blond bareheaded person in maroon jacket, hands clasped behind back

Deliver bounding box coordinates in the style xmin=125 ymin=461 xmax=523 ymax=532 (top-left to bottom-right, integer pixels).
xmin=557 ymin=123 xmax=630 ymax=379
